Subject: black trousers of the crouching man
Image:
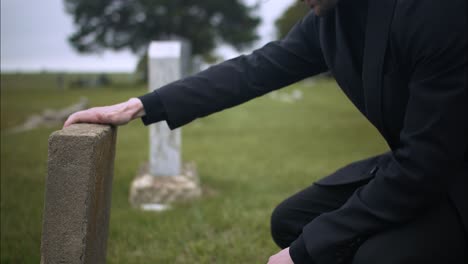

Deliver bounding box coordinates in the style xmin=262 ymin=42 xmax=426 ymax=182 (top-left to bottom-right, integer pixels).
xmin=271 ymin=181 xmax=468 ymax=264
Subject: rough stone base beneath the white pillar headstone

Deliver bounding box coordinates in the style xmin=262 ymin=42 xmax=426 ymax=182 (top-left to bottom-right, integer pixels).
xmin=129 ymin=163 xmax=202 ymax=209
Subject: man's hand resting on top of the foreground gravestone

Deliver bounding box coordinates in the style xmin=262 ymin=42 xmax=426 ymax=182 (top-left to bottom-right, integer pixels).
xmin=63 ymin=98 xmax=145 ymax=128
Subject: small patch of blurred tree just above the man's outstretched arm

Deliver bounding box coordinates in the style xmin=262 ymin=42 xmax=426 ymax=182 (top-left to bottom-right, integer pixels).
xmin=275 ymin=1 xmax=310 ymax=39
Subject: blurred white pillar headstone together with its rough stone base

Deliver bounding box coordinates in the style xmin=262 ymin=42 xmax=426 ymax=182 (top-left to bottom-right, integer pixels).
xmin=130 ymin=41 xmax=201 ymax=210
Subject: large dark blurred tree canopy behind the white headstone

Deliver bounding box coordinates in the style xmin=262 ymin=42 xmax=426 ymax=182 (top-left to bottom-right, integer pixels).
xmin=64 ymin=0 xmax=260 ymax=56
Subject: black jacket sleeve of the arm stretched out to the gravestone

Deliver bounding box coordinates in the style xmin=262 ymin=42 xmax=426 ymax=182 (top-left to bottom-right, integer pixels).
xmin=140 ymin=13 xmax=327 ymax=129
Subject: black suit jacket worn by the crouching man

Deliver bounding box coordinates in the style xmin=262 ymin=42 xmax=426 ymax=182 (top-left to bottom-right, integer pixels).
xmin=141 ymin=0 xmax=468 ymax=263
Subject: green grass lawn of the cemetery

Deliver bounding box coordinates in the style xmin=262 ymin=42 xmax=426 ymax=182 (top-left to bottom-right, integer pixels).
xmin=1 ymin=74 xmax=387 ymax=264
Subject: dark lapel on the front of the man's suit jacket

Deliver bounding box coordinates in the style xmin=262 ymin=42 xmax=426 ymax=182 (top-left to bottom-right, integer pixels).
xmin=362 ymin=0 xmax=396 ymax=136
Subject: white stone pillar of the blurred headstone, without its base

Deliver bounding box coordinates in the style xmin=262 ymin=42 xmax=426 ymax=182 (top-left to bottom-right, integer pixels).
xmin=148 ymin=41 xmax=189 ymax=176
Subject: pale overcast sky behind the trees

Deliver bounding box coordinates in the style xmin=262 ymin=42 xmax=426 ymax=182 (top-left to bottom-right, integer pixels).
xmin=0 ymin=0 xmax=297 ymax=71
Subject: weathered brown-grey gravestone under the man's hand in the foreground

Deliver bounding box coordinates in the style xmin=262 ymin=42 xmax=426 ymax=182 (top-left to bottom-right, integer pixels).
xmin=41 ymin=124 xmax=117 ymax=263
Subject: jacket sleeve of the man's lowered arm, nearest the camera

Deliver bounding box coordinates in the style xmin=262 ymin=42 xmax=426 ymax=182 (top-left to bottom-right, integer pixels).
xmin=290 ymin=0 xmax=468 ymax=264
